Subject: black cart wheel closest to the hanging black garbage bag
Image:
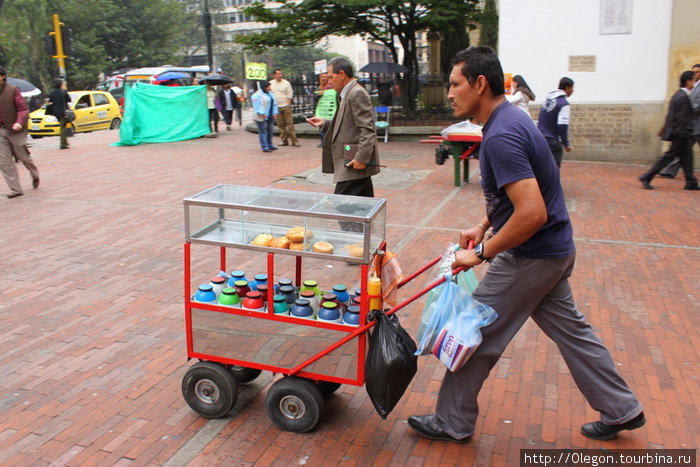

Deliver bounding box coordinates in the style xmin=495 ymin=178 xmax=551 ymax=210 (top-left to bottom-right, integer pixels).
xmin=265 ymin=376 xmax=323 ymax=433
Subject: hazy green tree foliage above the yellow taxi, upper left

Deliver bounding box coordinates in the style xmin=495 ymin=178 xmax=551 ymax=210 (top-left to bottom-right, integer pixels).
xmin=0 ymin=0 xmax=201 ymax=89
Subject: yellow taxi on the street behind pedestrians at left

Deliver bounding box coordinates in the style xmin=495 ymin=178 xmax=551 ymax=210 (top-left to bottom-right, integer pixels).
xmin=27 ymin=91 xmax=122 ymax=138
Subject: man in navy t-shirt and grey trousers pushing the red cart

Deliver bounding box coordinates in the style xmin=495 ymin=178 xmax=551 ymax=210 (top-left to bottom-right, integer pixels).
xmin=408 ymin=47 xmax=645 ymax=442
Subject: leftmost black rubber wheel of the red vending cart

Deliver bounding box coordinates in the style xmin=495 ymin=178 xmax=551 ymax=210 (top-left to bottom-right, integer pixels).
xmin=182 ymin=362 xmax=238 ymax=418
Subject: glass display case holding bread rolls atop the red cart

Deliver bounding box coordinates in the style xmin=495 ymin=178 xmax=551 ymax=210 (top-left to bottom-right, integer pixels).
xmin=184 ymin=185 xmax=386 ymax=264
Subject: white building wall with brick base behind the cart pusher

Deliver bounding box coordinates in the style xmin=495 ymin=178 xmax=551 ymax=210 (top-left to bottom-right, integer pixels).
xmin=499 ymin=0 xmax=700 ymax=162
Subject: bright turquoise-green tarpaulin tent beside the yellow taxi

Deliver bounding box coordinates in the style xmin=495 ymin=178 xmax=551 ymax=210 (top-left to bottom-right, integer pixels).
xmin=115 ymin=83 xmax=209 ymax=146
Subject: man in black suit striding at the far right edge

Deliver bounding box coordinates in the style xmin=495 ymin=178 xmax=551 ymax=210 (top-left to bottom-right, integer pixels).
xmin=639 ymin=71 xmax=700 ymax=191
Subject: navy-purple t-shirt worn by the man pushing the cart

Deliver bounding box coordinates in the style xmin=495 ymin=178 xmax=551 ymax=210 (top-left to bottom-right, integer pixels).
xmin=479 ymin=102 xmax=574 ymax=259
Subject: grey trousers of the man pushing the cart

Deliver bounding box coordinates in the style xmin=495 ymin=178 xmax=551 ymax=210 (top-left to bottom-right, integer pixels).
xmin=436 ymin=252 xmax=642 ymax=439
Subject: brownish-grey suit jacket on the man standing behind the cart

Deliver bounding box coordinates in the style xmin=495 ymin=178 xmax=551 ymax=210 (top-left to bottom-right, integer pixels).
xmin=321 ymin=81 xmax=379 ymax=183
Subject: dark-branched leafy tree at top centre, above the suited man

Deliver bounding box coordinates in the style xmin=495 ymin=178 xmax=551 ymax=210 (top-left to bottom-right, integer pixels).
xmin=237 ymin=0 xmax=477 ymax=106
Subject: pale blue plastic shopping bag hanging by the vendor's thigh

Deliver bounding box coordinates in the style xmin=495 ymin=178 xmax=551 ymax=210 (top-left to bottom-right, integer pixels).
xmin=416 ymin=275 xmax=498 ymax=371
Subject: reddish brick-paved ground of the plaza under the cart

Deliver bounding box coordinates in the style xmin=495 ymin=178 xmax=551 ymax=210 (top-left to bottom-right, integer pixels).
xmin=0 ymin=128 xmax=700 ymax=466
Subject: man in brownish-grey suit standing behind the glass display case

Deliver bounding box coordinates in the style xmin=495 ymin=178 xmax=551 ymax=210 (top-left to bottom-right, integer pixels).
xmin=306 ymin=57 xmax=379 ymax=197
